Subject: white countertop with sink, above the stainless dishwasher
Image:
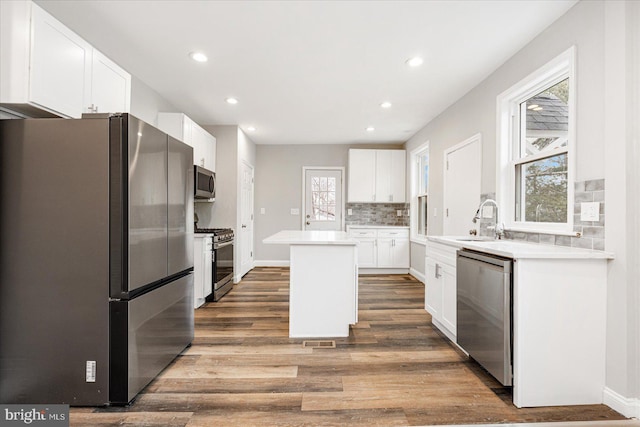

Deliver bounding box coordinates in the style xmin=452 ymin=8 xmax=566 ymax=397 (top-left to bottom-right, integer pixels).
xmin=427 ymin=236 xmax=613 ymax=259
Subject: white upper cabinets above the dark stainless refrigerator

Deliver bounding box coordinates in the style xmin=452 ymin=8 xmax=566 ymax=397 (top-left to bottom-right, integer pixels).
xmin=0 ymin=1 xmax=131 ymax=118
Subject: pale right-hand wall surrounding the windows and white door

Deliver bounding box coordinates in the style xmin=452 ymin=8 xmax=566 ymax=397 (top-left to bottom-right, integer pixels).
xmin=405 ymin=1 xmax=640 ymax=412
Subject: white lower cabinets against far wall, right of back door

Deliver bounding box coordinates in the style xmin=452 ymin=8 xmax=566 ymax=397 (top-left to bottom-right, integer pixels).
xmin=349 ymin=227 xmax=410 ymax=269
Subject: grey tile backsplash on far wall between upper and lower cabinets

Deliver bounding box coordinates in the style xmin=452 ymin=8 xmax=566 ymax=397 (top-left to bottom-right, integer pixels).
xmin=345 ymin=203 xmax=409 ymax=226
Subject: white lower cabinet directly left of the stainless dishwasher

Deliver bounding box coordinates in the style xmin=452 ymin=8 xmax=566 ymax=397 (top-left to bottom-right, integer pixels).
xmin=424 ymin=242 xmax=457 ymax=342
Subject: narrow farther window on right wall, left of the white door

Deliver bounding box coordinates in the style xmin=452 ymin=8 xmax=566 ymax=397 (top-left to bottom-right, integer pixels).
xmin=411 ymin=142 xmax=429 ymax=240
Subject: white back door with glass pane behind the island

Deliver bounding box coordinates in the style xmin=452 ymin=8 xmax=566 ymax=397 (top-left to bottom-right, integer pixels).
xmin=303 ymin=169 xmax=344 ymax=230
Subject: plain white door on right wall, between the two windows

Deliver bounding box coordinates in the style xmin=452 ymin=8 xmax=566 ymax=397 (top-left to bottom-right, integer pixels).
xmin=443 ymin=134 xmax=482 ymax=236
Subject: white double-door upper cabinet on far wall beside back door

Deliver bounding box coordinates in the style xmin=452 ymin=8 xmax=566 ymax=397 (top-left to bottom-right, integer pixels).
xmin=348 ymin=149 xmax=406 ymax=203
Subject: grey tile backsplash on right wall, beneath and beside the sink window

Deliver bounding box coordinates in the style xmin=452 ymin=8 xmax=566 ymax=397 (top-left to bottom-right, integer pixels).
xmin=480 ymin=179 xmax=605 ymax=251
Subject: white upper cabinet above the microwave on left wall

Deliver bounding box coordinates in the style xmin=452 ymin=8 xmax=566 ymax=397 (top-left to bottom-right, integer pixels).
xmin=158 ymin=113 xmax=216 ymax=172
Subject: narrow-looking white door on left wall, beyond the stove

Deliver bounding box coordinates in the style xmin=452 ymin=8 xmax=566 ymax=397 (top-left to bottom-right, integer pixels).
xmin=238 ymin=162 xmax=254 ymax=277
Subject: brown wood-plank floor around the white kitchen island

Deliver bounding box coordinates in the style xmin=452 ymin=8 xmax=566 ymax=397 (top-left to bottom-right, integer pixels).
xmin=71 ymin=268 xmax=624 ymax=427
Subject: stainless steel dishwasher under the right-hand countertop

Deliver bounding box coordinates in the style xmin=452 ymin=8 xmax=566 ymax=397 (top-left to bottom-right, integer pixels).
xmin=457 ymin=249 xmax=513 ymax=386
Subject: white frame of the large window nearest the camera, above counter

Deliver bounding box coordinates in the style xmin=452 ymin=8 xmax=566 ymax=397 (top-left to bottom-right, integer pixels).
xmin=496 ymin=46 xmax=577 ymax=236
